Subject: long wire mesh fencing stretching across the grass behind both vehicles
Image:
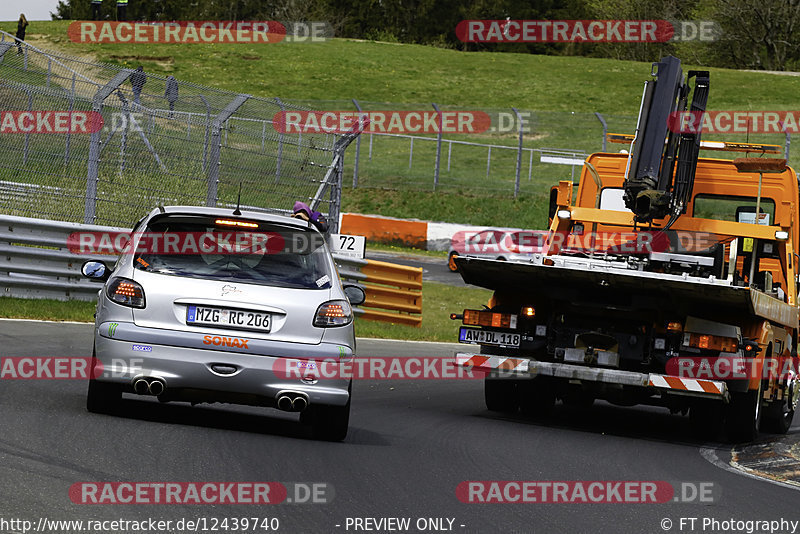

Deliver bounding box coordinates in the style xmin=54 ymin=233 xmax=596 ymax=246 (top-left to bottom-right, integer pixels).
xmin=0 ymin=33 xmax=800 ymax=216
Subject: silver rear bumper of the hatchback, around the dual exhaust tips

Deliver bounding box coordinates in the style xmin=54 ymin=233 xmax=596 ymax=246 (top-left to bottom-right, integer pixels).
xmin=93 ymin=323 xmax=352 ymax=406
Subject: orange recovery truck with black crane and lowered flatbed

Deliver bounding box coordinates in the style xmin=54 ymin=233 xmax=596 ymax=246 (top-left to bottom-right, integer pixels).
xmin=451 ymin=57 xmax=800 ymax=442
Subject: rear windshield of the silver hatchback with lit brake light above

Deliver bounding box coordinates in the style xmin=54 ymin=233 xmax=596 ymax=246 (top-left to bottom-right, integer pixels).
xmin=133 ymin=215 xmax=333 ymax=289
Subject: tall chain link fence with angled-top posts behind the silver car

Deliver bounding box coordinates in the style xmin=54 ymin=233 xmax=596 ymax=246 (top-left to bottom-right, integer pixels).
xmin=0 ymin=30 xmax=355 ymax=226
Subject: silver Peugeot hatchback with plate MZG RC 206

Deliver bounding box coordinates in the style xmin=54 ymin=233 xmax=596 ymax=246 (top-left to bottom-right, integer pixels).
xmin=83 ymin=206 xmax=364 ymax=441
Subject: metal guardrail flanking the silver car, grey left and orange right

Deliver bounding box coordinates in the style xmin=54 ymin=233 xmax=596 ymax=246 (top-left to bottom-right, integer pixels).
xmin=0 ymin=215 xmax=422 ymax=326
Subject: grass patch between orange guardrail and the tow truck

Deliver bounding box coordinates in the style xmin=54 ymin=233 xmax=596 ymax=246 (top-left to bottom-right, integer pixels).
xmin=356 ymin=282 xmax=492 ymax=342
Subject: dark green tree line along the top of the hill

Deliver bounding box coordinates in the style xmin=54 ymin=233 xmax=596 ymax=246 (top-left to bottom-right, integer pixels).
xmin=53 ymin=0 xmax=800 ymax=70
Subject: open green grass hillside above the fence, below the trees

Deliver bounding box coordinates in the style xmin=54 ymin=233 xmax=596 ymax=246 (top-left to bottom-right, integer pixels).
xmin=9 ymin=21 xmax=800 ymax=115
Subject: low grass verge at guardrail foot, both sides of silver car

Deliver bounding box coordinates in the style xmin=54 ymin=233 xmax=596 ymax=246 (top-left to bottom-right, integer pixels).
xmin=0 ymin=282 xmax=491 ymax=341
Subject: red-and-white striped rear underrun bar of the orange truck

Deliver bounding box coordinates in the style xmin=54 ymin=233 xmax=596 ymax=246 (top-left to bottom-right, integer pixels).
xmin=455 ymin=353 xmax=730 ymax=401
